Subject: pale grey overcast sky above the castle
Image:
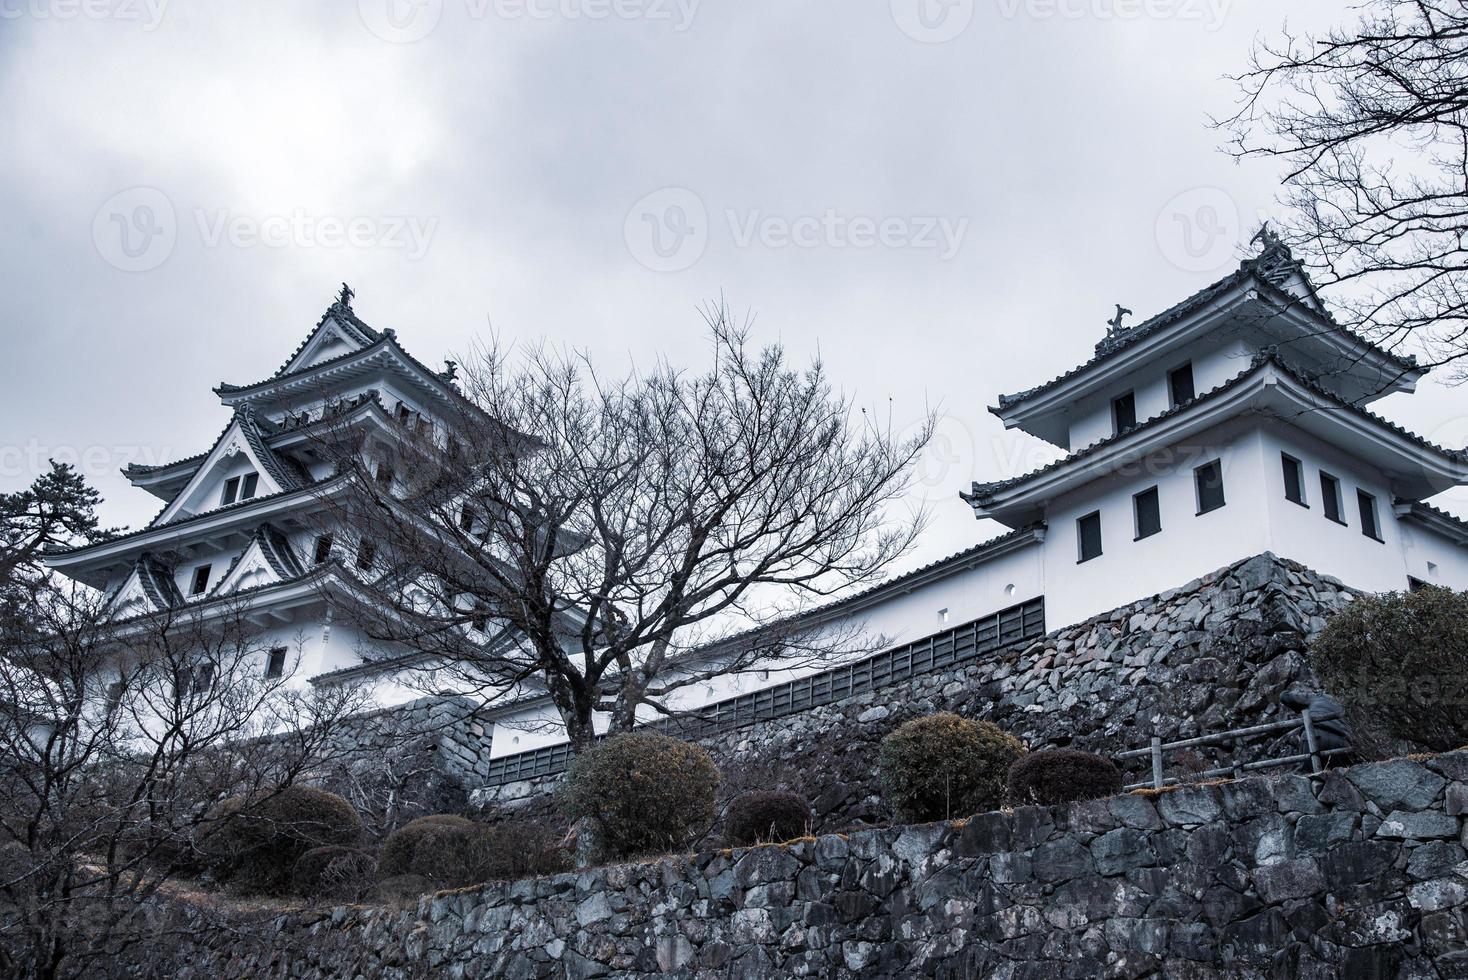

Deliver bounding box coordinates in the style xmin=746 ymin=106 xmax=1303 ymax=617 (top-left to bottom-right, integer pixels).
xmin=0 ymin=0 xmax=1468 ymax=565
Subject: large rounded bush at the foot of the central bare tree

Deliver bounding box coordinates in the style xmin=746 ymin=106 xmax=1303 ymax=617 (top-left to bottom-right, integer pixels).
xmin=559 ymin=732 xmax=719 ymax=858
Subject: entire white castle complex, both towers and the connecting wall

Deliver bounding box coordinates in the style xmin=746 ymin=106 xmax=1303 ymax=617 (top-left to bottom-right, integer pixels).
xmin=40 ymin=235 xmax=1468 ymax=782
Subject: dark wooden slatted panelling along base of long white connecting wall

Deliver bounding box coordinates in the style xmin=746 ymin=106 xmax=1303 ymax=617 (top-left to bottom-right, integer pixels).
xmin=486 ymin=596 xmax=1045 ymax=786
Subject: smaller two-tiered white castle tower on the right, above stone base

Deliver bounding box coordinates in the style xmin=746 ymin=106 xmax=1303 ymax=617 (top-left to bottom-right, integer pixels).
xmin=964 ymin=230 xmax=1468 ymax=628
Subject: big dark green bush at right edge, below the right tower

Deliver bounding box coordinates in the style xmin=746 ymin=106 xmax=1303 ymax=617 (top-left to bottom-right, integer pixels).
xmin=1309 ymin=585 xmax=1468 ymax=751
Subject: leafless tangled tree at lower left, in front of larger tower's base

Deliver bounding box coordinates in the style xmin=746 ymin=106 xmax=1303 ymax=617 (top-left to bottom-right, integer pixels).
xmin=0 ymin=584 xmax=372 ymax=977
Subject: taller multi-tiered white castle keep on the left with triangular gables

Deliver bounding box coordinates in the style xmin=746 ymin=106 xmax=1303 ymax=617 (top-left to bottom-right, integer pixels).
xmin=47 ymin=285 xmax=464 ymax=692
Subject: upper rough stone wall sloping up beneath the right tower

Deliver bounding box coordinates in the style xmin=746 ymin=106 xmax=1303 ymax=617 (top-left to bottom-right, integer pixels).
xmin=474 ymin=553 xmax=1362 ymax=830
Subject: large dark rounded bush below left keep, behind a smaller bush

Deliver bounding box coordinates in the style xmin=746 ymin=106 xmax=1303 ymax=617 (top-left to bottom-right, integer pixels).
xmin=200 ymin=786 xmax=363 ymax=895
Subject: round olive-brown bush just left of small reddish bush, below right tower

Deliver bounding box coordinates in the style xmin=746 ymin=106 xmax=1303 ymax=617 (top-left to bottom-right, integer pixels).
xmin=876 ymin=712 xmax=1025 ymax=822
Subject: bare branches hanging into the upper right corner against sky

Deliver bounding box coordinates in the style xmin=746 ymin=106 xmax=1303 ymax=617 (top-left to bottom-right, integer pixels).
xmin=1218 ymin=0 xmax=1468 ymax=380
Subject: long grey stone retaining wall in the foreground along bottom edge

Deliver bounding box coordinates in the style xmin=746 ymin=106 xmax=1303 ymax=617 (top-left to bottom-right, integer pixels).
xmin=126 ymin=753 xmax=1468 ymax=980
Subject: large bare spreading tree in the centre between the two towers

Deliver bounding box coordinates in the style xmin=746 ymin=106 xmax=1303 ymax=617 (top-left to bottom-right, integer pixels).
xmin=330 ymin=307 xmax=932 ymax=750
